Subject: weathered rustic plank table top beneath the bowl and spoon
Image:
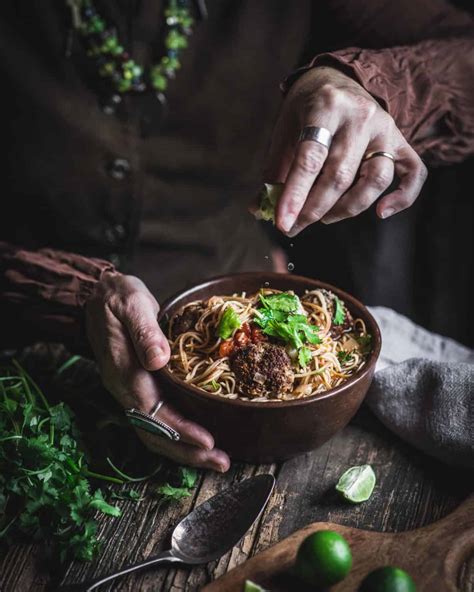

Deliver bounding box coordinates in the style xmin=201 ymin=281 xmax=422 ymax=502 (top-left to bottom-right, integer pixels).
xmin=0 ymin=350 xmax=474 ymax=592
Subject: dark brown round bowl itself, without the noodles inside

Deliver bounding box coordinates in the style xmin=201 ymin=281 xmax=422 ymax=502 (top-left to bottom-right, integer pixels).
xmin=158 ymin=272 xmax=381 ymax=463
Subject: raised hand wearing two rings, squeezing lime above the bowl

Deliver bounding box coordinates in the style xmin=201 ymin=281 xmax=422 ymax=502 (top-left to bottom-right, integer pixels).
xmin=266 ymin=67 xmax=427 ymax=236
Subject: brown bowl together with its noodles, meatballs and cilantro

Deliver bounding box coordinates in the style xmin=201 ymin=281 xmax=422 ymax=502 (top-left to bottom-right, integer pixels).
xmin=156 ymin=272 xmax=381 ymax=463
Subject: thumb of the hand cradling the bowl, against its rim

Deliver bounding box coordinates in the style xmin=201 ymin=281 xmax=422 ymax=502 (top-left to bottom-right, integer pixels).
xmin=121 ymin=297 xmax=170 ymax=371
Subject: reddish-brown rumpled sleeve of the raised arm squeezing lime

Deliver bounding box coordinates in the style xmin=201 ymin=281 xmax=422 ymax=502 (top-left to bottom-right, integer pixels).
xmin=283 ymin=35 xmax=474 ymax=164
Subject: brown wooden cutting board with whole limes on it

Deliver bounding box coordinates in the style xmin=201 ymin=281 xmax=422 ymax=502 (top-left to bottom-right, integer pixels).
xmin=203 ymin=496 xmax=474 ymax=592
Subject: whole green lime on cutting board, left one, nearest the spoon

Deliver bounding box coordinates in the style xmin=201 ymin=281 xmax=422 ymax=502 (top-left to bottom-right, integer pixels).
xmin=295 ymin=530 xmax=352 ymax=588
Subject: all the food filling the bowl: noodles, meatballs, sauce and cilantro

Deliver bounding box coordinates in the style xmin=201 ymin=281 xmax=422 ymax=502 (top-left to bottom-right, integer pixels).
xmin=168 ymin=288 xmax=371 ymax=403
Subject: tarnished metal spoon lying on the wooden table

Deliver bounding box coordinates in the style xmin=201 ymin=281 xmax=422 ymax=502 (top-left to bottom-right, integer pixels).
xmin=58 ymin=474 xmax=275 ymax=592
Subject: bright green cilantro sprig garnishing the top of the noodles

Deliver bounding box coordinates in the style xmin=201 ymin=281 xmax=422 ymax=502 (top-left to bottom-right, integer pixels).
xmin=254 ymin=292 xmax=321 ymax=368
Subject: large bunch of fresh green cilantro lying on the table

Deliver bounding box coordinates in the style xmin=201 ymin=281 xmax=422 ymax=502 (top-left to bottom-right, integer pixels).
xmin=0 ymin=363 xmax=120 ymax=560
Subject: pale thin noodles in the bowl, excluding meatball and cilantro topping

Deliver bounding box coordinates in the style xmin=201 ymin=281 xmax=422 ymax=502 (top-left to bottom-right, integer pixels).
xmin=168 ymin=288 xmax=370 ymax=402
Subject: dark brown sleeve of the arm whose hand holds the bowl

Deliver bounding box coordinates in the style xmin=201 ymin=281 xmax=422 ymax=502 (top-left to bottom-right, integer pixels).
xmin=0 ymin=242 xmax=114 ymax=351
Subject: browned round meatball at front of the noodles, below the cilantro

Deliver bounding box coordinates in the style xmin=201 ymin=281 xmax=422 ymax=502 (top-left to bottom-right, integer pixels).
xmin=230 ymin=342 xmax=295 ymax=397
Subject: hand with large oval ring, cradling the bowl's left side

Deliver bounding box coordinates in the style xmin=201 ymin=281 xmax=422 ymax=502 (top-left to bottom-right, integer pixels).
xmin=85 ymin=273 xmax=230 ymax=472
